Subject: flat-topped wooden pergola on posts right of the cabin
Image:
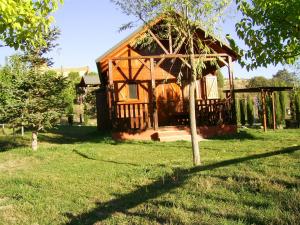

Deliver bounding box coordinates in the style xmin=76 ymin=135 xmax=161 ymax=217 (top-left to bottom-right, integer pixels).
xmin=224 ymin=87 xmax=293 ymax=131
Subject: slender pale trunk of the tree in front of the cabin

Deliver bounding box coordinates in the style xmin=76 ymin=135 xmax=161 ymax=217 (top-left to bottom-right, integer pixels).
xmin=189 ymin=49 xmax=201 ymax=166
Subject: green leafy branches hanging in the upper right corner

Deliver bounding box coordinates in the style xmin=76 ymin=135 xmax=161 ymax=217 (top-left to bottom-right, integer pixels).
xmin=236 ymin=0 xmax=300 ymax=70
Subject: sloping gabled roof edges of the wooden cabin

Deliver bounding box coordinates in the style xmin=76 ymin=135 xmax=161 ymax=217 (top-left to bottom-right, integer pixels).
xmin=95 ymin=17 xmax=238 ymax=68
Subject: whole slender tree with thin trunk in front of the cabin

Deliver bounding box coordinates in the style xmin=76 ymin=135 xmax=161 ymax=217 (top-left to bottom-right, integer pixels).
xmin=112 ymin=0 xmax=230 ymax=165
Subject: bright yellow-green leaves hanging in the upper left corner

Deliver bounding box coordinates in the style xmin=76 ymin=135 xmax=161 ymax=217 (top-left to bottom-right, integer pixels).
xmin=0 ymin=0 xmax=63 ymax=50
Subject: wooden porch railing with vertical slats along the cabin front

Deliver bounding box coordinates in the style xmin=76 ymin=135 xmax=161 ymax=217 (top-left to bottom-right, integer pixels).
xmin=114 ymin=99 xmax=235 ymax=130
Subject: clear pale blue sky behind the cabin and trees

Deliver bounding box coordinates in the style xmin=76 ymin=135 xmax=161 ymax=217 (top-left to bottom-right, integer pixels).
xmin=0 ymin=0 xmax=282 ymax=78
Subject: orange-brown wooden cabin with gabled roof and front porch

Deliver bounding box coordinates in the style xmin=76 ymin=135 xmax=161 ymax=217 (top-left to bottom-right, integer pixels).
xmin=96 ymin=20 xmax=237 ymax=140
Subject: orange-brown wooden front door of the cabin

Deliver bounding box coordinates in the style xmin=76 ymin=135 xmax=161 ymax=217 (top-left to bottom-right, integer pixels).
xmin=156 ymin=83 xmax=183 ymax=126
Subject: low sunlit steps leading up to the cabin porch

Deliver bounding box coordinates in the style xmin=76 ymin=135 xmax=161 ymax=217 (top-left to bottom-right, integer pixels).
xmin=153 ymin=126 xmax=203 ymax=142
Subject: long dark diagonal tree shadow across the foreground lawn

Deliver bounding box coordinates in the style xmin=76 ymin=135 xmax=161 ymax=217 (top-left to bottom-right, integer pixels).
xmin=65 ymin=146 xmax=300 ymax=224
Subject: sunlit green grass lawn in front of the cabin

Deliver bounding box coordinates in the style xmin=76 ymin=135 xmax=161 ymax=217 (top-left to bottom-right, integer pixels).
xmin=0 ymin=127 xmax=300 ymax=224
